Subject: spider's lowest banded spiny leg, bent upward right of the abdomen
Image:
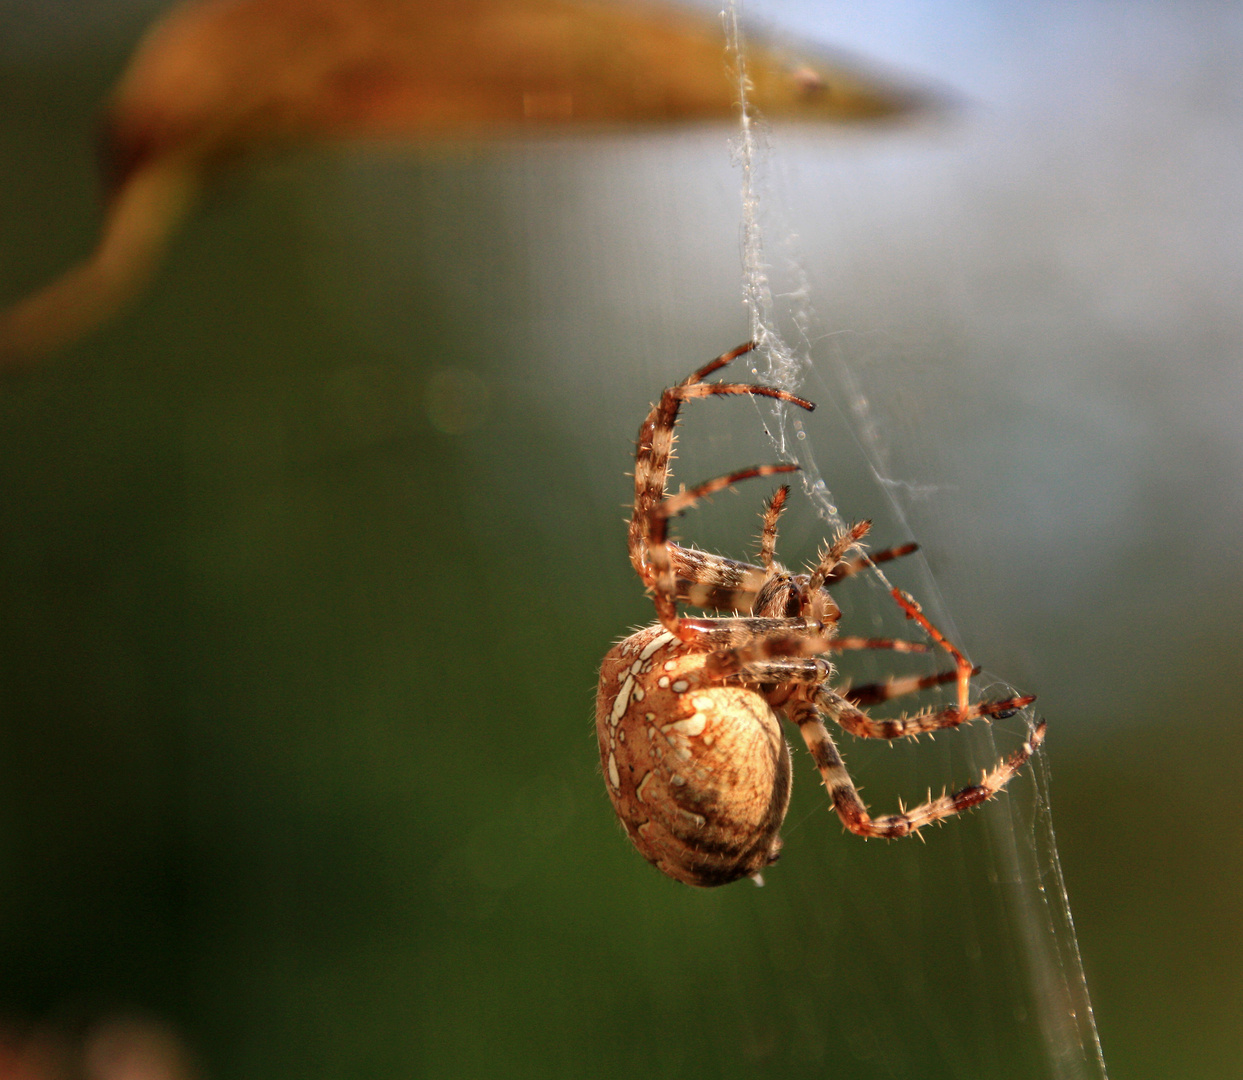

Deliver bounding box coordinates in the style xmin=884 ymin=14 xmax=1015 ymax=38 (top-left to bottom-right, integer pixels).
xmin=789 ymin=701 xmax=1045 ymax=838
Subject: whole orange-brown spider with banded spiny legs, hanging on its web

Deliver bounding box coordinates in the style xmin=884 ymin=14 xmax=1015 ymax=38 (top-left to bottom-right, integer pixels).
xmin=595 ymin=342 xmax=1045 ymax=886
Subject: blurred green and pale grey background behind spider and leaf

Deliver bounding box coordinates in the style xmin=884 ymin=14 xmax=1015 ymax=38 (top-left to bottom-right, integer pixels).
xmin=0 ymin=0 xmax=1243 ymax=1080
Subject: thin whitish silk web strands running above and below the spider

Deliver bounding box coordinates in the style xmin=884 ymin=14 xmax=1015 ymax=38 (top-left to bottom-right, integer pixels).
xmin=722 ymin=0 xmax=1106 ymax=1080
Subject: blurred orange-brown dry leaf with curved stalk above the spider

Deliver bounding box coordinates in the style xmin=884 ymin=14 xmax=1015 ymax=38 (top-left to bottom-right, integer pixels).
xmin=0 ymin=0 xmax=916 ymax=367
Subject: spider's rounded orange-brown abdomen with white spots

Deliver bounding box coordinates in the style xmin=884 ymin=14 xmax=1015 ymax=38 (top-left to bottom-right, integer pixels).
xmin=595 ymin=625 xmax=791 ymax=886
